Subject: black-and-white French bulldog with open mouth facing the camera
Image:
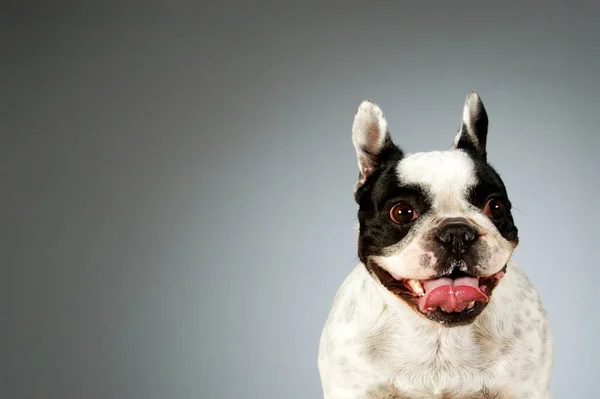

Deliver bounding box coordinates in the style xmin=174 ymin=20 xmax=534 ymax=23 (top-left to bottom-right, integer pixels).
xmin=318 ymin=92 xmax=553 ymax=399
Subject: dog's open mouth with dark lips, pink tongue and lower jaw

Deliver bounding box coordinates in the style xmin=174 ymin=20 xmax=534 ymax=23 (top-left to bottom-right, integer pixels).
xmin=368 ymin=261 xmax=506 ymax=327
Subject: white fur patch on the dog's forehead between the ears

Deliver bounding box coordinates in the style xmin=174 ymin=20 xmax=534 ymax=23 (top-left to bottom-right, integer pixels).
xmin=396 ymin=150 xmax=477 ymax=195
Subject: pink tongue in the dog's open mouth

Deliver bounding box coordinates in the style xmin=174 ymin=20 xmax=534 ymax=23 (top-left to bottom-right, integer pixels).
xmin=419 ymin=277 xmax=488 ymax=312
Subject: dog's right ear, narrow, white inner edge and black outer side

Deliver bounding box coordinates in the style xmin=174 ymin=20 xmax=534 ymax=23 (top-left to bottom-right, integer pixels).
xmin=452 ymin=91 xmax=488 ymax=161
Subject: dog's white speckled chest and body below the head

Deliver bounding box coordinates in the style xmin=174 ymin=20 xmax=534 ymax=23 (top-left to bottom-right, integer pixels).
xmin=318 ymin=261 xmax=552 ymax=399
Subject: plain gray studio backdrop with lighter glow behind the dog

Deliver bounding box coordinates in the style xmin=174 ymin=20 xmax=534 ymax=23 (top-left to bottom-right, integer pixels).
xmin=0 ymin=1 xmax=600 ymax=399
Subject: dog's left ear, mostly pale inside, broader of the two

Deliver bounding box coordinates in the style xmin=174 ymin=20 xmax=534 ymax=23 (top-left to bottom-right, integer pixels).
xmin=352 ymin=100 xmax=402 ymax=191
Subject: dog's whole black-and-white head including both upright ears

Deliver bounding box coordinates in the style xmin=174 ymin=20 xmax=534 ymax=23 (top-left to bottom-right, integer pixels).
xmin=352 ymin=92 xmax=518 ymax=326
